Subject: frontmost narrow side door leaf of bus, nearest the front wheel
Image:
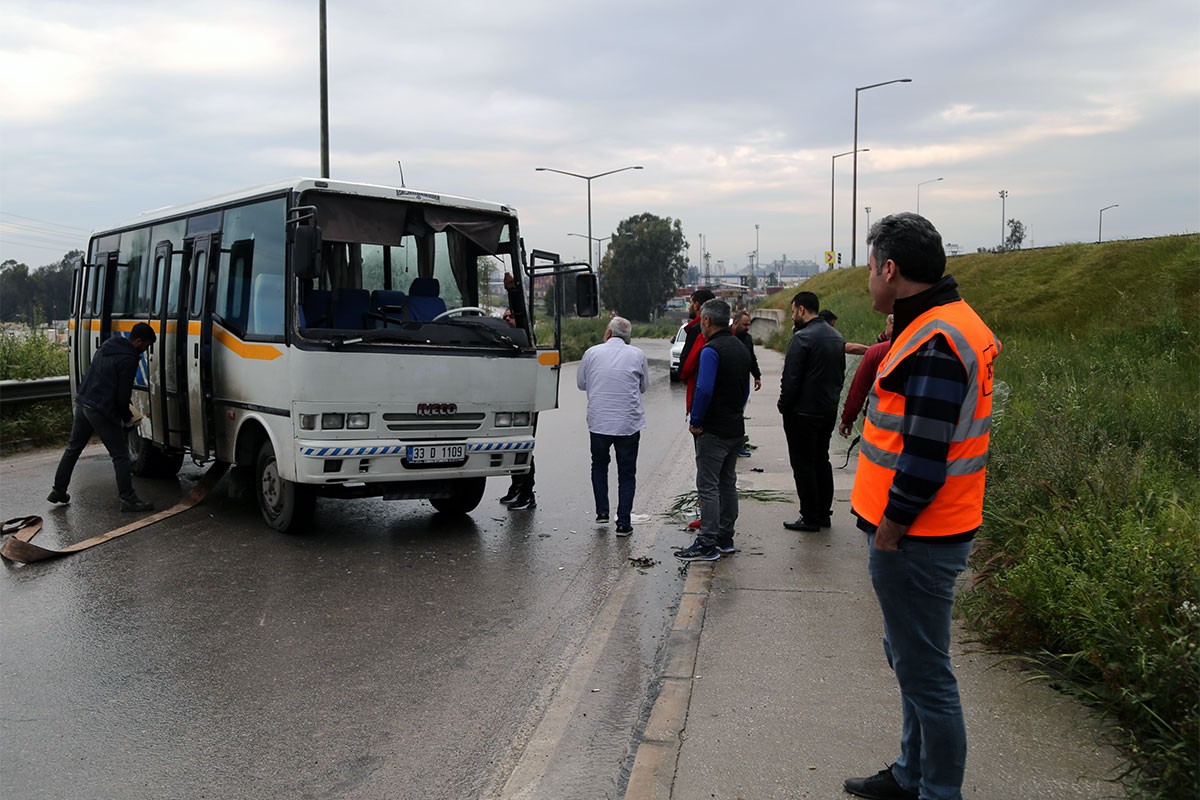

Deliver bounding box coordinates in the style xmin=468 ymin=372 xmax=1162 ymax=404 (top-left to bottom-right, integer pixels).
xmin=184 ymin=234 xmax=221 ymax=461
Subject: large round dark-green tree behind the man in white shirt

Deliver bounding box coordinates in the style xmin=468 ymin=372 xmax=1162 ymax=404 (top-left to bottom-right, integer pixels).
xmin=600 ymin=212 xmax=688 ymax=320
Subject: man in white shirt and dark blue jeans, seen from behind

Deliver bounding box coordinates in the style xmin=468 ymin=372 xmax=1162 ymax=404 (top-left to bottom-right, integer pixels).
xmin=575 ymin=317 xmax=650 ymax=536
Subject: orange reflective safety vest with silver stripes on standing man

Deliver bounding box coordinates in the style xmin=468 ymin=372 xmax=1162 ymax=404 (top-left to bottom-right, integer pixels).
xmin=851 ymin=300 xmax=1000 ymax=536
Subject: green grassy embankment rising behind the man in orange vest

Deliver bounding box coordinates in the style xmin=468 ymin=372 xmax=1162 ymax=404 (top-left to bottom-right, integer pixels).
xmin=770 ymin=235 xmax=1200 ymax=799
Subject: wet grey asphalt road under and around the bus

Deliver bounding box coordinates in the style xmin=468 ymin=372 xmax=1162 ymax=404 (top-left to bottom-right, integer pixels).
xmin=0 ymin=341 xmax=692 ymax=800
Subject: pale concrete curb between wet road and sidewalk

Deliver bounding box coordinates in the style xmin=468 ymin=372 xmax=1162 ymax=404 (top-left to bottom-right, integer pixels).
xmin=625 ymin=561 xmax=713 ymax=800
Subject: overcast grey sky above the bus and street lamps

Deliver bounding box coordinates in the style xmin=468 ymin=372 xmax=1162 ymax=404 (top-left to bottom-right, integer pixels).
xmin=0 ymin=0 xmax=1200 ymax=271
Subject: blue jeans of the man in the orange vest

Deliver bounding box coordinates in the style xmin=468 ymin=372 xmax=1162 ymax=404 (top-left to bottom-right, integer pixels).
xmin=866 ymin=535 xmax=972 ymax=800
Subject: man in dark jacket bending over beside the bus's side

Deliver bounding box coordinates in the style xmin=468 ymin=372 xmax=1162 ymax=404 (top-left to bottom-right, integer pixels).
xmin=46 ymin=323 xmax=157 ymax=511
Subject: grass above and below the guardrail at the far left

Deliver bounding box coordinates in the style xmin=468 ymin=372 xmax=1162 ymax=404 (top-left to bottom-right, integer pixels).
xmin=0 ymin=328 xmax=71 ymax=451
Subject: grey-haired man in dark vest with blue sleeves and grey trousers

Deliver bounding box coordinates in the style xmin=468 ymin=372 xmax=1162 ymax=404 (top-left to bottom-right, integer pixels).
xmin=676 ymin=300 xmax=750 ymax=561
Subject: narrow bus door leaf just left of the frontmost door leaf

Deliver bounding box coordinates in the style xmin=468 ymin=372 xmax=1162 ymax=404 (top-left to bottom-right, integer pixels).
xmin=150 ymin=240 xmax=190 ymax=449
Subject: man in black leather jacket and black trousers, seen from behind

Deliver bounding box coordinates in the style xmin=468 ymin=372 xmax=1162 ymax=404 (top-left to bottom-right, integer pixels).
xmin=779 ymin=291 xmax=846 ymax=531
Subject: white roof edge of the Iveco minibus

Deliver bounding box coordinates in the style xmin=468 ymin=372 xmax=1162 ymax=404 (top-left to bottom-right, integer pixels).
xmin=89 ymin=178 xmax=516 ymax=239
